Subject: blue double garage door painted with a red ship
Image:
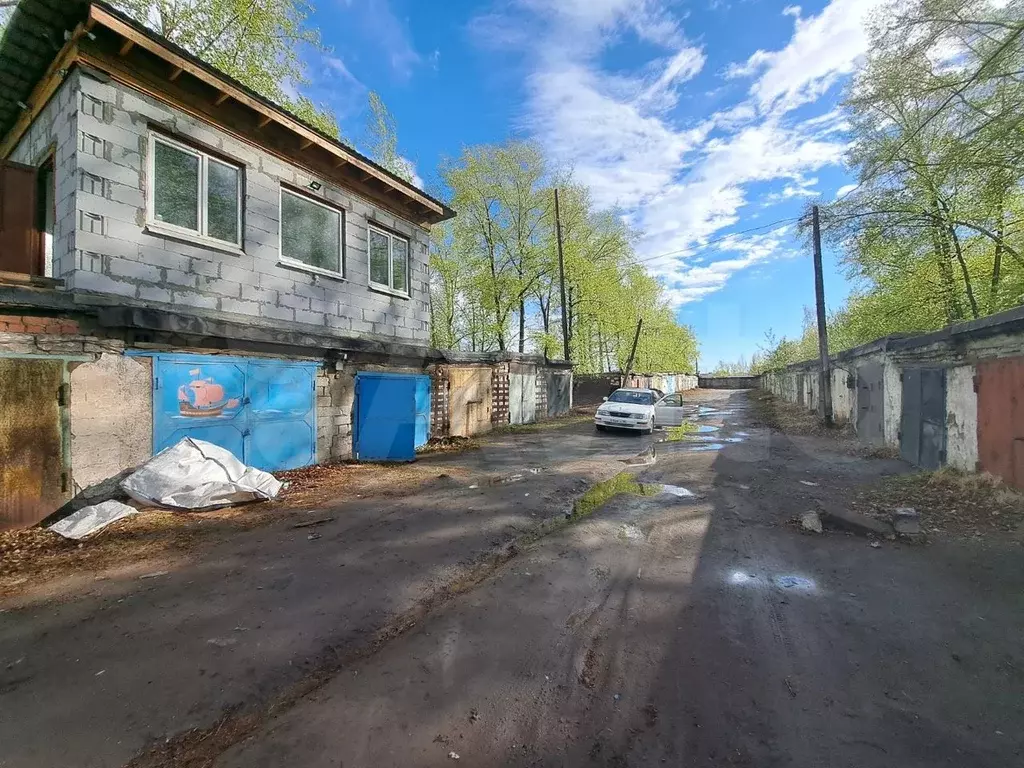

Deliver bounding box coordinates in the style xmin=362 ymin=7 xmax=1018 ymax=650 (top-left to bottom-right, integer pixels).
xmin=146 ymin=354 xmax=317 ymax=471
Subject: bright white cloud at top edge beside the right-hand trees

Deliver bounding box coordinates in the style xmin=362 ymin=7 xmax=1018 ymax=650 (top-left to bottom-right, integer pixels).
xmin=727 ymin=0 xmax=880 ymax=111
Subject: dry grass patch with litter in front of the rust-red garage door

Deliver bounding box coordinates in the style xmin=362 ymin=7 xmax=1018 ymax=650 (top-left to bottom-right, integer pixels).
xmin=854 ymin=468 xmax=1024 ymax=536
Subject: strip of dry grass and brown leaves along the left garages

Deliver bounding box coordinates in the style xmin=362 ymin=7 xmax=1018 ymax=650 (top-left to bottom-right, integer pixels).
xmin=0 ymin=464 xmax=465 ymax=597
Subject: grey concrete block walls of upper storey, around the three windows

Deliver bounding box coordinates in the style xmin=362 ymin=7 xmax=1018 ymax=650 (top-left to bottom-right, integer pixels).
xmin=15 ymin=71 xmax=429 ymax=344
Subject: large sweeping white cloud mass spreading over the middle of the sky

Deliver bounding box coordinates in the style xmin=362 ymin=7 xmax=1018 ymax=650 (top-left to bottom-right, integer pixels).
xmin=471 ymin=0 xmax=866 ymax=305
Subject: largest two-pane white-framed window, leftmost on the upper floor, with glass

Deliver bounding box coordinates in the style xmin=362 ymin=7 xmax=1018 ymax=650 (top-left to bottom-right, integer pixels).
xmin=146 ymin=131 xmax=242 ymax=248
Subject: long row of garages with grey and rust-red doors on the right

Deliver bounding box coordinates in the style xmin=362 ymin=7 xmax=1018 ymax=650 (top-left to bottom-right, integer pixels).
xmin=763 ymin=308 xmax=1024 ymax=489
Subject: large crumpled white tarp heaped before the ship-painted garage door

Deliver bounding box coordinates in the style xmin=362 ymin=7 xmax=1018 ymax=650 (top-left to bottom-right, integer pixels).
xmin=121 ymin=437 xmax=282 ymax=509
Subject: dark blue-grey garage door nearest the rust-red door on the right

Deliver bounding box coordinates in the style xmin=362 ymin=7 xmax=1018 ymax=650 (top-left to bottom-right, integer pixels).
xmin=899 ymin=368 xmax=946 ymax=469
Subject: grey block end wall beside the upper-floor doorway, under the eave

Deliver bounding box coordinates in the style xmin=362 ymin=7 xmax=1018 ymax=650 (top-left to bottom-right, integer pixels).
xmin=9 ymin=71 xmax=80 ymax=278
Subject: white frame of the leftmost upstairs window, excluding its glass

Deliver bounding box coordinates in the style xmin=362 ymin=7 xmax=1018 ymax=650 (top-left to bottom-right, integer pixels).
xmin=145 ymin=130 xmax=245 ymax=251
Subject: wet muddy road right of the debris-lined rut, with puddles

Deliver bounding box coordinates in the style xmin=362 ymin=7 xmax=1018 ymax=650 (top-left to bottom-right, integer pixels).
xmin=216 ymin=393 xmax=1024 ymax=768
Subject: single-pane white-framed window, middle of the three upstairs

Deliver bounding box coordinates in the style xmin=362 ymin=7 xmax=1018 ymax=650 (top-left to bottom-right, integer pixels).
xmin=281 ymin=186 xmax=345 ymax=278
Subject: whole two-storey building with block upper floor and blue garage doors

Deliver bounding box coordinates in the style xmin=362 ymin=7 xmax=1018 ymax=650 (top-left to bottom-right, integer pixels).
xmin=0 ymin=0 xmax=462 ymax=526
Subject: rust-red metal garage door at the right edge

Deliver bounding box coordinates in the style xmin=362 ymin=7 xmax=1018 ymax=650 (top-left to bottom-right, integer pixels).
xmin=976 ymin=357 xmax=1024 ymax=490
